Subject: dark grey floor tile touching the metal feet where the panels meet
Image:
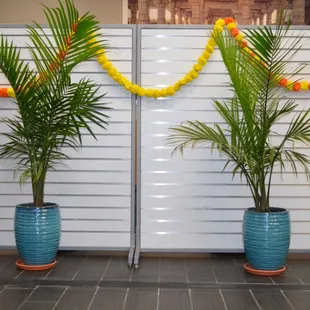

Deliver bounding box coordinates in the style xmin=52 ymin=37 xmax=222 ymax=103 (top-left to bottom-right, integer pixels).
xmin=132 ymin=258 xmax=159 ymax=283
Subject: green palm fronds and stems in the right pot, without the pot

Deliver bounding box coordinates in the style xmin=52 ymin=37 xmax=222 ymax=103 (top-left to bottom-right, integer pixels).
xmin=168 ymin=18 xmax=310 ymax=212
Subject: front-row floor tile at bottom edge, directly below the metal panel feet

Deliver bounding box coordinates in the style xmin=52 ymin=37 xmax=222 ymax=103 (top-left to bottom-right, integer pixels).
xmin=125 ymin=288 xmax=158 ymax=310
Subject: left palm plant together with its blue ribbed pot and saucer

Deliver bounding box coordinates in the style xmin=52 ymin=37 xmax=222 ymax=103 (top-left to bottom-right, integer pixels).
xmin=0 ymin=0 xmax=107 ymax=269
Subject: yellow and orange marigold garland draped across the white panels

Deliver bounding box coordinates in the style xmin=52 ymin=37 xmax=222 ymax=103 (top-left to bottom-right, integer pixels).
xmin=0 ymin=17 xmax=310 ymax=99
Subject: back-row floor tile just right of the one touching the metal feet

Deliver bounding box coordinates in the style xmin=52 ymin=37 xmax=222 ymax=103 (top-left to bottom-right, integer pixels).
xmin=159 ymin=258 xmax=187 ymax=282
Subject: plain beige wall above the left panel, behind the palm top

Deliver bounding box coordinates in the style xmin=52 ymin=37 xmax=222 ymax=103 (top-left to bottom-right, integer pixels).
xmin=0 ymin=0 xmax=123 ymax=24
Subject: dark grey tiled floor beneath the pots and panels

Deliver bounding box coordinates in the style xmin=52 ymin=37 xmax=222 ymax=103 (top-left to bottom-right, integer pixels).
xmin=0 ymin=253 xmax=310 ymax=310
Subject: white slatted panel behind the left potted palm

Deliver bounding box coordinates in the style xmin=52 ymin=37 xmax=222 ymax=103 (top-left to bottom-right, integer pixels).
xmin=0 ymin=26 xmax=133 ymax=249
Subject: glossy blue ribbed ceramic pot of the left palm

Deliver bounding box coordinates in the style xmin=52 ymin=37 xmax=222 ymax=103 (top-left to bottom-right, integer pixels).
xmin=14 ymin=203 xmax=61 ymax=265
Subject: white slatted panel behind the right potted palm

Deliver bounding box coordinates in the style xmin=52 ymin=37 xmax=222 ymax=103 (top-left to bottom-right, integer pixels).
xmin=141 ymin=26 xmax=310 ymax=251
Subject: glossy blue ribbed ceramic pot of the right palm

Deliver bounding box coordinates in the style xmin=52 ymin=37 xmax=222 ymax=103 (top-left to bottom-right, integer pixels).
xmin=243 ymin=208 xmax=291 ymax=270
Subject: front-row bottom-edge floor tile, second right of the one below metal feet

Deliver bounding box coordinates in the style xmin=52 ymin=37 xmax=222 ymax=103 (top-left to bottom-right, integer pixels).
xmin=190 ymin=290 xmax=225 ymax=310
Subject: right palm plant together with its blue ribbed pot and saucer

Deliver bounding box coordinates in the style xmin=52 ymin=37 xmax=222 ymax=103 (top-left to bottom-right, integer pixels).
xmin=168 ymin=18 xmax=310 ymax=274
